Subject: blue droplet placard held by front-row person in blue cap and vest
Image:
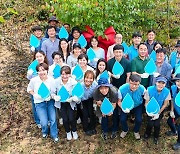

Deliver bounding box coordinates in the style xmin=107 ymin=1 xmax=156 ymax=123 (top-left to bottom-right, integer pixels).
xmin=146 ymin=97 xmax=160 ymax=114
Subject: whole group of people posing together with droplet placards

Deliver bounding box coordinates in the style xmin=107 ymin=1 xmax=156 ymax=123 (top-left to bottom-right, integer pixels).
xmin=27 ymin=16 xmax=180 ymax=150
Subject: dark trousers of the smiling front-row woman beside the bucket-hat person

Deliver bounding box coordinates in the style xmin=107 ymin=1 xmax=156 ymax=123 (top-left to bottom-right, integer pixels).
xmin=81 ymin=98 xmax=96 ymax=132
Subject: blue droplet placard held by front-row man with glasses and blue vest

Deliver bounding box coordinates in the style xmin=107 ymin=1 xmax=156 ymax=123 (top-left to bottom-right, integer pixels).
xmin=121 ymin=93 xmax=134 ymax=111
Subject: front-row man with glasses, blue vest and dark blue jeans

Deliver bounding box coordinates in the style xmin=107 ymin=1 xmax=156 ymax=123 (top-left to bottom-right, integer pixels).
xmin=118 ymin=74 xmax=146 ymax=140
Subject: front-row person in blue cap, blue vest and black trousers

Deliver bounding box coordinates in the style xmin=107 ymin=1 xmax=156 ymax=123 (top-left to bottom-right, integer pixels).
xmin=144 ymin=75 xmax=171 ymax=144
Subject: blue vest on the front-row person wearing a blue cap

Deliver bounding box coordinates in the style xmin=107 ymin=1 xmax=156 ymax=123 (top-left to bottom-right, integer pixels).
xmin=147 ymin=85 xmax=170 ymax=108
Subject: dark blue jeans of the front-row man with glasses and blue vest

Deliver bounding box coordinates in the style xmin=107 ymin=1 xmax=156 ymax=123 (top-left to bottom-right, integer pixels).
xmin=120 ymin=104 xmax=143 ymax=133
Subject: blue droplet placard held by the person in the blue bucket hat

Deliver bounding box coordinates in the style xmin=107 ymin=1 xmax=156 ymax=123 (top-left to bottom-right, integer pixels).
xmin=100 ymin=97 xmax=114 ymax=115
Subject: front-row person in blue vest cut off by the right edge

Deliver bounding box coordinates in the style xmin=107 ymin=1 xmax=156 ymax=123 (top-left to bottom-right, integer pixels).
xmin=166 ymin=74 xmax=180 ymax=150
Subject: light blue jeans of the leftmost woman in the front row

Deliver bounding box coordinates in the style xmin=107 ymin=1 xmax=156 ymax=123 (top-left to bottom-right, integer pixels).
xmin=35 ymin=100 xmax=58 ymax=139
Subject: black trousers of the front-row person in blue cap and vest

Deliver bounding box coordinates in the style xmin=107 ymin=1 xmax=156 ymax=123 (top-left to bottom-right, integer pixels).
xmin=145 ymin=113 xmax=163 ymax=138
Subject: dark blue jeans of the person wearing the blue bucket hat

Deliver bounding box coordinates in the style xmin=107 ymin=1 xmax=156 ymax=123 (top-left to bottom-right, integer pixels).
xmin=101 ymin=107 xmax=118 ymax=133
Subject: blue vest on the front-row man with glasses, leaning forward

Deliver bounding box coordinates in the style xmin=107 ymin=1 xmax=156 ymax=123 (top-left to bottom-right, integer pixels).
xmin=119 ymin=83 xmax=145 ymax=108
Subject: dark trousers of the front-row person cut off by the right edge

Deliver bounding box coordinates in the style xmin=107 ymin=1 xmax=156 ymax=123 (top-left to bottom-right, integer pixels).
xmin=167 ymin=110 xmax=180 ymax=143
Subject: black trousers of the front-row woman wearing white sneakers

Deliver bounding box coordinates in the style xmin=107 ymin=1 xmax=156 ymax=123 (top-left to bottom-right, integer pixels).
xmin=61 ymin=102 xmax=77 ymax=133
